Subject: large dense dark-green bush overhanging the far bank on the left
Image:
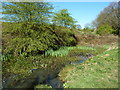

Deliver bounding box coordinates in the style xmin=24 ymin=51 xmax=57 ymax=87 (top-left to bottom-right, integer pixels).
xmin=3 ymin=23 xmax=76 ymax=56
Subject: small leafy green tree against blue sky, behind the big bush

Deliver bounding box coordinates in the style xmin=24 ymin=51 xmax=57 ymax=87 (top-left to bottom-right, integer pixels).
xmin=52 ymin=9 xmax=76 ymax=28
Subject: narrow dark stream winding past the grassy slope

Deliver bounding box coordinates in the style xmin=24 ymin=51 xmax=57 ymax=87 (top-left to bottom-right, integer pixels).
xmin=2 ymin=56 xmax=91 ymax=90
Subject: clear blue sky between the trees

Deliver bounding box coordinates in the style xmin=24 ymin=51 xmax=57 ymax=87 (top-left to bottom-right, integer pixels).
xmin=51 ymin=2 xmax=110 ymax=28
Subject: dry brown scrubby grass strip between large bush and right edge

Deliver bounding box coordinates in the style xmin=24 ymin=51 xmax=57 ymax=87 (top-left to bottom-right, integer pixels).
xmin=75 ymin=33 xmax=118 ymax=46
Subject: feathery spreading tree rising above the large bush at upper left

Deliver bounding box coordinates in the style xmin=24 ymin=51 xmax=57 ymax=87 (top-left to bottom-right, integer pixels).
xmin=2 ymin=2 xmax=53 ymax=23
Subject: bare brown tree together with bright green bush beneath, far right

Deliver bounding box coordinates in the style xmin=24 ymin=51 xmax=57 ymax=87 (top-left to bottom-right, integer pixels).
xmin=92 ymin=2 xmax=120 ymax=35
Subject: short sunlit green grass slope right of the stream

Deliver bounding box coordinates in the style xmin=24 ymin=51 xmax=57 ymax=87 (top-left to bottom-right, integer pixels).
xmin=59 ymin=49 xmax=118 ymax=88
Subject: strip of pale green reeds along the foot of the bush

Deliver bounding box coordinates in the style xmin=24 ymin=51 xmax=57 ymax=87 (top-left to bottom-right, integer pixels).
xmin=45 ymin=45 xmax=109 ymax=57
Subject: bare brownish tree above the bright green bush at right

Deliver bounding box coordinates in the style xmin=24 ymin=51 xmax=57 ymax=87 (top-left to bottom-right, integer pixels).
xmin=93 ymin=2 xmax=120 ymax=34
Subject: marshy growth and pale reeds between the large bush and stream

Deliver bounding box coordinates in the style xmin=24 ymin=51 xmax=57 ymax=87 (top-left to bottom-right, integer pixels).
xmin=1 ymin=46 xmax=108 ymax=77
